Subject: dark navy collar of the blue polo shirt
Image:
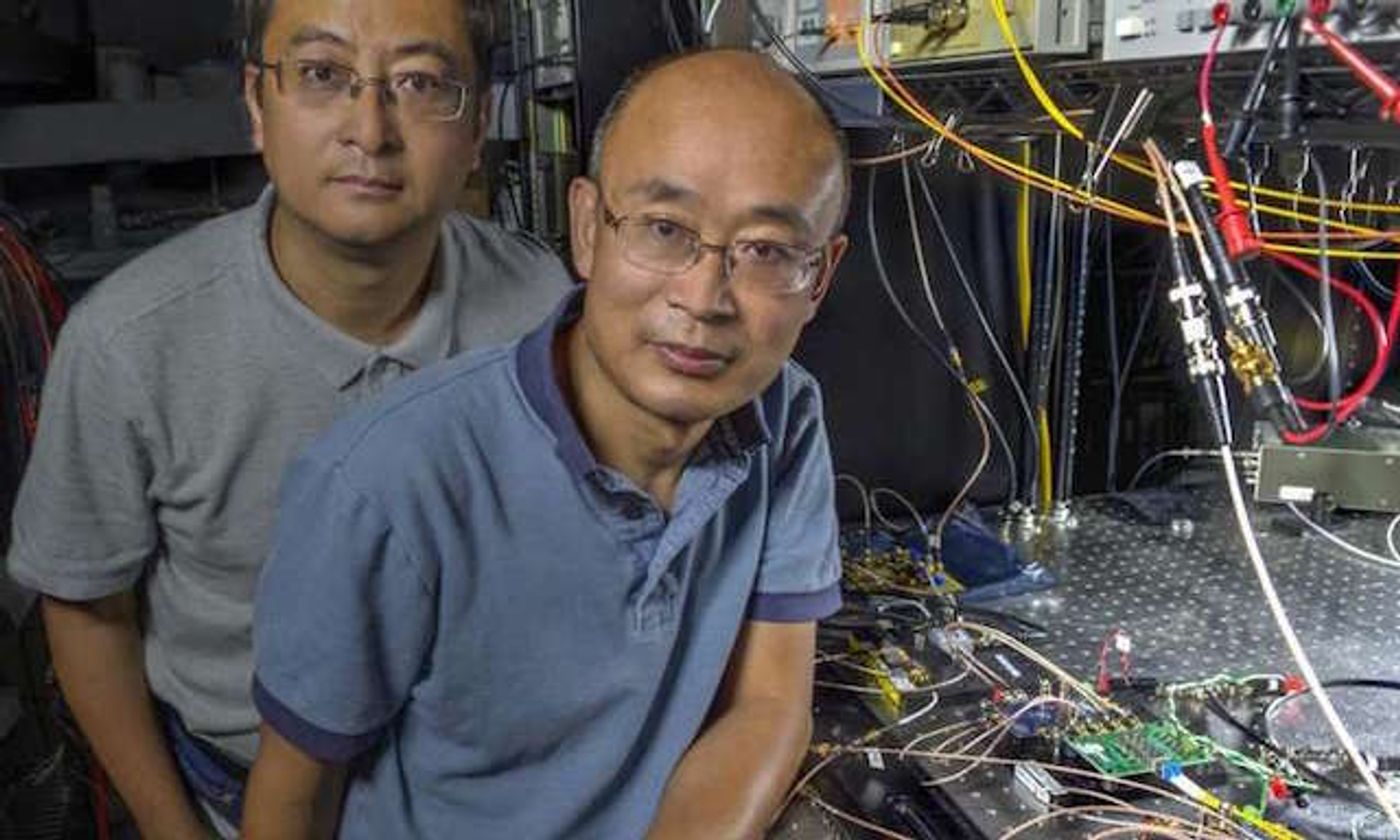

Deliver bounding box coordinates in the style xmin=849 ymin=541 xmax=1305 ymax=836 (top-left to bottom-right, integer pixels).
xmin=515 ymin=284 xmax=771 ymax=477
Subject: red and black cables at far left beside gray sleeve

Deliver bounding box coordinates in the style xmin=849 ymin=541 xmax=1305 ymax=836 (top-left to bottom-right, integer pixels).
xmin=0 ymin=209 xmax=66 ymax=545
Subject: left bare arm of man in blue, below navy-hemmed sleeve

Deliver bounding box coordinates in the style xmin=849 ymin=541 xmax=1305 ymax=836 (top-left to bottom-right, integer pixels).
xmin=242 ymin=724 xmax=344 ymax=840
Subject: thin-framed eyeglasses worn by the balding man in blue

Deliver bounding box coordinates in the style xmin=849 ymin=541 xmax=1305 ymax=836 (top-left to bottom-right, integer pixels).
xmin=603 ymin=204 xmax=826 ymax=295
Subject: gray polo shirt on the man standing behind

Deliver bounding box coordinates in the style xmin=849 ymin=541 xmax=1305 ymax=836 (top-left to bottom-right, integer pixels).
xmin=8 ymin=190 xmax=570 ymax=762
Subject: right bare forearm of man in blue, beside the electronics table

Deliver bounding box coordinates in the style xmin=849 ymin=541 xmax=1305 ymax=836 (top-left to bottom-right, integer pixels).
xmin=648 ymin=622 xmax=816 ymax=840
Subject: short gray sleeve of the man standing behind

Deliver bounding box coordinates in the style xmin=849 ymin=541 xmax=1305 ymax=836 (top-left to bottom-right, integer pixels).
xmin=8 ymin=316 xmax=158 ymax=601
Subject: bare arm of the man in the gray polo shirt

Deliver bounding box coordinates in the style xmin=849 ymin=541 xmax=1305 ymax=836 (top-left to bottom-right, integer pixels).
xmin=43 ymin=592 xmax=209 ymax=840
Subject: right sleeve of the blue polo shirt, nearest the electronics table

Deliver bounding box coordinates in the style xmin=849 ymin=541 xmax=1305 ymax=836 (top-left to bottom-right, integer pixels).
xmin=749 ymin=367 xmax=841 ymax=622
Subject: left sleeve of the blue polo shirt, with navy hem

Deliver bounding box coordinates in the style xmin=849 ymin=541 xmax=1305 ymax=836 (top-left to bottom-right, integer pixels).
xmin=253 ymin=458 xmax=435 ymax=763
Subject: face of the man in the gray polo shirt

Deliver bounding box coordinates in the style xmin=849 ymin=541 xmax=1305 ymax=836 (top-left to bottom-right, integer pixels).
xmin=245 ymin=0 xmax=490 ymax=248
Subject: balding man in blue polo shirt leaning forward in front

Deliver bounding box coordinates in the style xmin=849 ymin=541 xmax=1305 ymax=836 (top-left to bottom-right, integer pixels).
xmin=244 ymin=52 xmax=850 ymax=840
